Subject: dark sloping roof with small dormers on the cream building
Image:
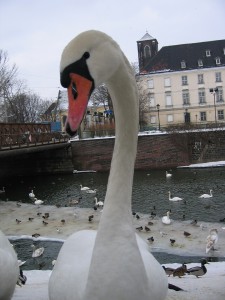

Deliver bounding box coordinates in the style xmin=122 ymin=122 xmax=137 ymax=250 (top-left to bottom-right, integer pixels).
xmin=141 ymin=40 xmax=225 ymax=73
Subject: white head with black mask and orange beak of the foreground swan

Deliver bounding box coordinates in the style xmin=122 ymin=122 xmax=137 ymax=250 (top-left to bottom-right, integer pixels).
xmin=60 ymin=30 xmax=123 ymax=135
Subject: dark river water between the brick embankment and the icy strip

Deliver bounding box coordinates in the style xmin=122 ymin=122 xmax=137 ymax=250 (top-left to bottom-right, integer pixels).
xmin=0 ymin=167 xmax=225 ymax=222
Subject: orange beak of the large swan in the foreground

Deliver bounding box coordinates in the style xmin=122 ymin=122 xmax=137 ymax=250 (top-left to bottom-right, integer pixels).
xmin=66 ymin=73 xmax=93 ymax=136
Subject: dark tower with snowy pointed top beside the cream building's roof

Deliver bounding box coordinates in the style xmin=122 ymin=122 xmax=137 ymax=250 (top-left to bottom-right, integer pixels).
xmin=137 ymin=31 xmax=158 ymax=73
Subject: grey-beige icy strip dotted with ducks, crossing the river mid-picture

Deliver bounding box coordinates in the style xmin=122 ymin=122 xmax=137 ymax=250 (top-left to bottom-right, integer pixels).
xmin=0 ymin=201 xmax=225 ymax=257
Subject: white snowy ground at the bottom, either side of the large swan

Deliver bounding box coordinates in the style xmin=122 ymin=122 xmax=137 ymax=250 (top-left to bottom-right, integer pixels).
xmin=12 ymin=262 xmax=225 ymax=300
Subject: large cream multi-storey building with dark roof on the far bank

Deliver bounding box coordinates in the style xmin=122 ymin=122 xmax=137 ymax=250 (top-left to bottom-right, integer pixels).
xmin=136 ymin=33 xmax=225 ymax=128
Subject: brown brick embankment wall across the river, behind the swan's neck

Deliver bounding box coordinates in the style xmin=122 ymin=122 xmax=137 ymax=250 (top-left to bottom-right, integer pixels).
xmin=71 ymin=130 xmax=225 ymax=171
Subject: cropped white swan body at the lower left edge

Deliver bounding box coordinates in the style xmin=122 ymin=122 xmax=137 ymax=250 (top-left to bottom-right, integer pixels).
xmin=0 ymin=231 xmax=19 ymax=299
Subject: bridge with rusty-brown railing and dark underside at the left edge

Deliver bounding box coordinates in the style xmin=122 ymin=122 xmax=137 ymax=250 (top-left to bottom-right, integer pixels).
xmin=0 ymin=123 xmax=73 ymax=178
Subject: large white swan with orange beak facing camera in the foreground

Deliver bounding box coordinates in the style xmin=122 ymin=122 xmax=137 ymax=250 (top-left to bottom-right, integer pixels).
xmin=49 ymin=31 xmax=168 ymax=300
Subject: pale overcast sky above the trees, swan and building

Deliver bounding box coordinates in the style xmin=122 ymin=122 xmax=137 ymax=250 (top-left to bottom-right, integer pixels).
xmin=0 ymin=0 xmax=225 ymax=100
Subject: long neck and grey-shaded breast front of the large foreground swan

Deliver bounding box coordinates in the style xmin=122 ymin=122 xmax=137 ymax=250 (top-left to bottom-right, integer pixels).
xmin=85 ymin=59 xmax=149 ymax=300
